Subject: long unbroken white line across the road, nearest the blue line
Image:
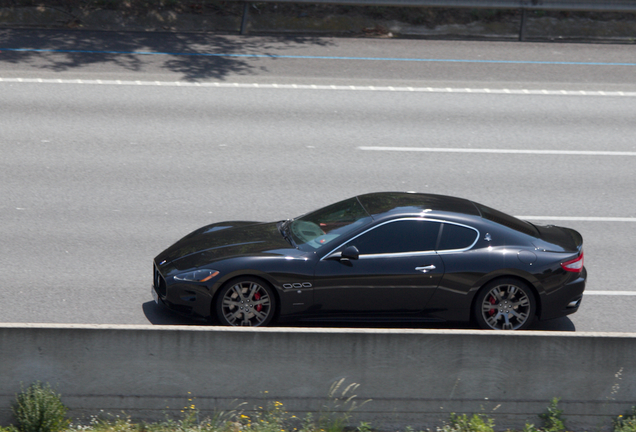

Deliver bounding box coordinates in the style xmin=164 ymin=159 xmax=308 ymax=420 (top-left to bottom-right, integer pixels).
xmin=0 ymin=77 xmax=636 ymax=97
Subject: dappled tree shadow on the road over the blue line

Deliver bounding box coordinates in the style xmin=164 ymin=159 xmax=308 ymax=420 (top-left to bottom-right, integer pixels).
xmin=0 ymin=29 xmax=336 ymax=82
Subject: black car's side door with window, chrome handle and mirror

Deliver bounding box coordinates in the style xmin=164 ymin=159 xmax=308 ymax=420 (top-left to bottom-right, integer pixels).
xmin=314 ymin=218 xmax=444 ymax=318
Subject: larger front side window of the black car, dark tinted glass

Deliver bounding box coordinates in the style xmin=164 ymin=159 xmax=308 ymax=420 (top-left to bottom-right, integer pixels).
xmin=348 ymin=220 xmax=441 ymax=255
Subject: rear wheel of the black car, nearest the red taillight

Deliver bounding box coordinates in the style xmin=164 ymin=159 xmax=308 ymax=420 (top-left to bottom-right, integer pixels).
xmin=474 ymin=278 xmax=537 ymax=330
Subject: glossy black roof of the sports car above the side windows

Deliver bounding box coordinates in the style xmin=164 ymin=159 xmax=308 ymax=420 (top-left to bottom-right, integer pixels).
xmin=357 ymin=192 xmax=481 ymax=219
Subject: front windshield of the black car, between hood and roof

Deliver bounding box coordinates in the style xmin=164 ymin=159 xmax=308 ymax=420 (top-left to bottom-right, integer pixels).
xmin=289 ymin=198 xmax=372 ymax=251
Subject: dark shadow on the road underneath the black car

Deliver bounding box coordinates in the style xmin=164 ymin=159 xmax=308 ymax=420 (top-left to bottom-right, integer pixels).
xmin=142 ymin=301 xmax=576 ymax=332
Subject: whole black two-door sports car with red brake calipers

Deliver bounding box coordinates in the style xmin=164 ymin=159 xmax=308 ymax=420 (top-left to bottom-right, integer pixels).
xmin=152 ymin=192 xmax=587 ymax=330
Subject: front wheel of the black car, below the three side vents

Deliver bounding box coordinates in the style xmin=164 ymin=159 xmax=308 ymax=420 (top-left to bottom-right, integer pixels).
xmin=216 ymin=277 xmax=276 ymax=327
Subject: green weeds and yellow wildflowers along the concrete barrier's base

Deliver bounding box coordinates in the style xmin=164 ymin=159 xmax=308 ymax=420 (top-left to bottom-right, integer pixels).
xmin=0 ymin=380 xmax=636 ymax=432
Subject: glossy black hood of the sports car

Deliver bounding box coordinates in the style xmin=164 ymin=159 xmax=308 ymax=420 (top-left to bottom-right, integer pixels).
xmin=155 ymin=221 xmax=291 ymax=269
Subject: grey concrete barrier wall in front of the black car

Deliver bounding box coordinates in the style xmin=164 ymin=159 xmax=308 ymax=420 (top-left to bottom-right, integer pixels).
xmin=0 ymin=324 xmax=636 ymax=430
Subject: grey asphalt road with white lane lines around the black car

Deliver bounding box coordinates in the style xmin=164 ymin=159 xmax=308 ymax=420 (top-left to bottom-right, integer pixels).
xmin=0 ymin=30 xmax=636 ymax=332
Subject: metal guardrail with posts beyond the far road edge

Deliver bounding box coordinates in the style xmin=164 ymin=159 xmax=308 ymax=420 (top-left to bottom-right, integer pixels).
xmin=241 ymin=0 xmax=636 ymax=41
